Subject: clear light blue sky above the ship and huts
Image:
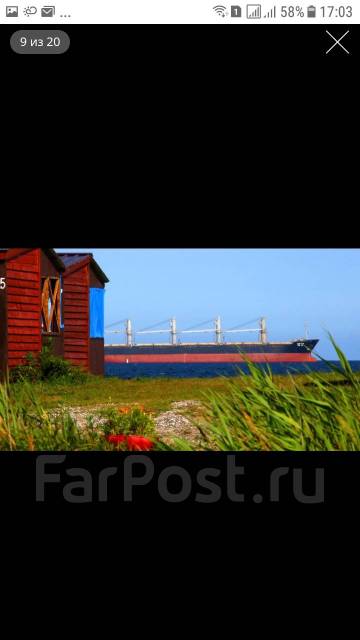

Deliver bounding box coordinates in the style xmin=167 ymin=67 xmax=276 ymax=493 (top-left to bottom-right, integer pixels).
xmin=57 ymin=249 xmax=360 ymax=360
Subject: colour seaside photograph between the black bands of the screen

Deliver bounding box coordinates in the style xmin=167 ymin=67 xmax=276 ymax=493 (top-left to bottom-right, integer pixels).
xmin=0 ymin=248 xmax=360 ymax=455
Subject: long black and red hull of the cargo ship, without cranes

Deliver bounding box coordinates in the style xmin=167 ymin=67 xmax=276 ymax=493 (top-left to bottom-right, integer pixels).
xmin=105 ymin=340 xmax=317 ymax=364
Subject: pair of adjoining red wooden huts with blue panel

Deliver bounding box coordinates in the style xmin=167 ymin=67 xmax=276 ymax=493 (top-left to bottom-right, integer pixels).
xmin=0 ymin=248 xmax=108 ymax=376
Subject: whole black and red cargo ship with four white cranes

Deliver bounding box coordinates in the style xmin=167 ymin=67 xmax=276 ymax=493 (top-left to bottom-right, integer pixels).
xmin=105 ymin=318 xmax=319 ymax=364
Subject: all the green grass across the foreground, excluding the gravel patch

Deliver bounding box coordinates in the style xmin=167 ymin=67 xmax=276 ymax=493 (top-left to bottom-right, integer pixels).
xmin=0 ymin=336 xmax=360 ymax=451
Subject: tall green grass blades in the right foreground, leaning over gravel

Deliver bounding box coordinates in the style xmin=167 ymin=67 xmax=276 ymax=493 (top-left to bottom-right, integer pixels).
xmin=178 ymin=336 xmax=360 ymax=451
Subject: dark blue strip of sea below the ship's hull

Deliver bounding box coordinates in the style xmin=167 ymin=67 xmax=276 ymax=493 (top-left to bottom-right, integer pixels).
xmin=105 ymin=360 xmax=360 ymax=380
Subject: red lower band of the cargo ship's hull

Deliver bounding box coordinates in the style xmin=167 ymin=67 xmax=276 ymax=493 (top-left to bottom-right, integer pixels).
xmin=105 ymin=353 xmax=316 ymax=364
